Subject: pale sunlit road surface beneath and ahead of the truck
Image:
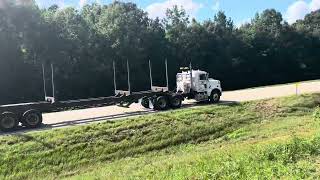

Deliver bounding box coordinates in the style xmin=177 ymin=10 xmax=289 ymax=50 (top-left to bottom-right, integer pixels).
xmin=43 ymin=81 xmax=320 ymax=128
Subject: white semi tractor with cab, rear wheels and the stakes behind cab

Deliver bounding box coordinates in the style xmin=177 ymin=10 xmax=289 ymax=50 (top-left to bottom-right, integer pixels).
xmin=141 ymin=63 xmax=222 ymax=110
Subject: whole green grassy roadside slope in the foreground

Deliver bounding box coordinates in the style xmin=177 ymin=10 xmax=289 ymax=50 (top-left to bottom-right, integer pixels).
xmin=0 ymin=94 xmax=320 ymax=179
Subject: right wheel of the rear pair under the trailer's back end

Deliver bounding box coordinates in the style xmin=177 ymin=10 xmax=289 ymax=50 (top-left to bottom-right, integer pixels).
xmin=21 ymin=110 xmax=42 ymax=128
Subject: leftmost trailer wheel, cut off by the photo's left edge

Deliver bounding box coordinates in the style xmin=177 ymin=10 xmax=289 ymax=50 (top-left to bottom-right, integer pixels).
xmin=0 ymin=112 xmax=19 ymax=132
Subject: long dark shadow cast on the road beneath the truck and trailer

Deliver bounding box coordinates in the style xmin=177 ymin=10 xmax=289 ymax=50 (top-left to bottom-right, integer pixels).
xmin=0 ymin=101 xmax=239 ymax=136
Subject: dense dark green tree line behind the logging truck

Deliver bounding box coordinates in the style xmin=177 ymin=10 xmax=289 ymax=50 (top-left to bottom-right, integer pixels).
xmin=0 ymin=0 xmax=320 ymax=104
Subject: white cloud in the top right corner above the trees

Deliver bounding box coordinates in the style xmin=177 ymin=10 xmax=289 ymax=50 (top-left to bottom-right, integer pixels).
xmin=285 ymin=0 xmax=320 ymax=24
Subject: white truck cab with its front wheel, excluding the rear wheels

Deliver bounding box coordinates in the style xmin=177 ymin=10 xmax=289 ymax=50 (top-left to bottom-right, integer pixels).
xmin=177 ymin=70 xmax=222 ymax=103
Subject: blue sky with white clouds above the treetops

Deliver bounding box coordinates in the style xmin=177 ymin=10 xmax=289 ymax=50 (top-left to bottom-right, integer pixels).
xmin=36 ymin=0 xmax=320 ymax=26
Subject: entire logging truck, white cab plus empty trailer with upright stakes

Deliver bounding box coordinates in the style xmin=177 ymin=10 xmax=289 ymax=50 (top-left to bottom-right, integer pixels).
xmin=0 ymin=61 xmax=222 ymax=131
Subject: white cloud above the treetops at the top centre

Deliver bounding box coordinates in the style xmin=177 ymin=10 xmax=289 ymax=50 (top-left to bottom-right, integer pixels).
xmin=146 ymin=0 xmax=203 ymax=18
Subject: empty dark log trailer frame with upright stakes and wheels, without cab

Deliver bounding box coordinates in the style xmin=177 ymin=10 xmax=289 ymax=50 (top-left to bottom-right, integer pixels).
xmin=0 ymin=60 xmax=184 ymax=131
